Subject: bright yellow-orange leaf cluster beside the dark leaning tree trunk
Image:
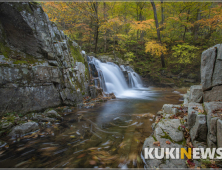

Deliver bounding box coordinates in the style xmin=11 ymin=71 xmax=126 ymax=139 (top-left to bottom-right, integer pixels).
xmin=145 ymin=40 xmax=167 ymax=56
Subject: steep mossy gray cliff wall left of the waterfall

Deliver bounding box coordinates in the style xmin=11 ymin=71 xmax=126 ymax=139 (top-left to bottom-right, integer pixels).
xmin=0 ymin=2 xmax=89 ymax=116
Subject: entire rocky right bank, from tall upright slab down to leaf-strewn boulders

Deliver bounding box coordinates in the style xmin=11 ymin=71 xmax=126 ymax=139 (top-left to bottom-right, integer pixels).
xmin=142 ymin=44 xmax=222 ymax=168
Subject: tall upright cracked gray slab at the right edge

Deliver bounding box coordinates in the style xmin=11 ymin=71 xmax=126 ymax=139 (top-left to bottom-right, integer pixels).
xmin=201 ymin=44 xmax=222 ymax=102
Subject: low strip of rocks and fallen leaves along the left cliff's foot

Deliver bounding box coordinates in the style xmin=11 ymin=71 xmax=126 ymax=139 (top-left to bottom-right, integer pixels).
xmin=0 ymin=93 xmax=116 ymax=139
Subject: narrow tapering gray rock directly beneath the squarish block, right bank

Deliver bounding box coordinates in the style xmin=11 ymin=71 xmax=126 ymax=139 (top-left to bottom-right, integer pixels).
xmin=187 ymin=103 xmax=203 ymax=129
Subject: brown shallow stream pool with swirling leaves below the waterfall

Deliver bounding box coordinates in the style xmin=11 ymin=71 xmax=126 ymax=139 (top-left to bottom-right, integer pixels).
xmin=0 ymin=88 xmax=185 ymax=168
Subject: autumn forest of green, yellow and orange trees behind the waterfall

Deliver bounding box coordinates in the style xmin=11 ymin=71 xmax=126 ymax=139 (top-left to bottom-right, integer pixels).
xmin=42 ymin=1 xmax=222 ymax=82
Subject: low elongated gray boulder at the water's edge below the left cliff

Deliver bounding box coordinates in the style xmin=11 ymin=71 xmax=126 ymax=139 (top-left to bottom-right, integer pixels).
xmin=9 ymin=122 xmax=39 ymax=137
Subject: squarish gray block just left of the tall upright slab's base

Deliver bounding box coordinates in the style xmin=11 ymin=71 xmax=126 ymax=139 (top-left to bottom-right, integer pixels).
xmin=189 ymin=85 xmax=203 ymax=103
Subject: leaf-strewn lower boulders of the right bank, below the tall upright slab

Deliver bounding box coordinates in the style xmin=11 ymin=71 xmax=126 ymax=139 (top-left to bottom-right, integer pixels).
xmin=142 ymin=87 xmax=222 ymax=168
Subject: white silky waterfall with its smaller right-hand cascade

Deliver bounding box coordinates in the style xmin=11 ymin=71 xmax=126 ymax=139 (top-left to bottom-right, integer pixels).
xmin=87 ymin=56 xmax=143 ymax=97
